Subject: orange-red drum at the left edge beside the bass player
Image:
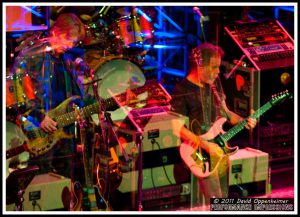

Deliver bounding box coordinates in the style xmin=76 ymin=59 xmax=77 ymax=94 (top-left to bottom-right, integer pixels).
xmin=6 ymin=74 xmax=35 ymax=108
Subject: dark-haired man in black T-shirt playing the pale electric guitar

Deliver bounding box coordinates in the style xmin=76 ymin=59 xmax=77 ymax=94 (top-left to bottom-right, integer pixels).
xmin=171 ymin=43 xmax=257 ymax=209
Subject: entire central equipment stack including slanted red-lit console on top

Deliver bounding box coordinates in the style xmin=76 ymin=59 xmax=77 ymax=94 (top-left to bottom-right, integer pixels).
xmin=111 ymin=81 xmax=191 ymax=210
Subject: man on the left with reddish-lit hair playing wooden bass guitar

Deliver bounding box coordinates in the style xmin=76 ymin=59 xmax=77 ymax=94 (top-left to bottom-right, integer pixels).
xmin=9 ymin=13 xmax=91 ymax=209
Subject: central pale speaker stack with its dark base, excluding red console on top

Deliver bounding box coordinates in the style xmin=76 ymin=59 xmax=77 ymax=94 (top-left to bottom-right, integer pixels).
xmin=110 ymin=112 xmax=191 ymax=210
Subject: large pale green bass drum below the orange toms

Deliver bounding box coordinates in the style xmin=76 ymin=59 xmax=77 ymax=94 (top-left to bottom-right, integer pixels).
xmin=88 ymin=58 xmax=146 ymax=124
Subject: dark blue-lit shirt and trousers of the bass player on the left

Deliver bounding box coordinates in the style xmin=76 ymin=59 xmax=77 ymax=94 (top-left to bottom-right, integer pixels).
xmin=13 ymin=43 xmax=90 ymax=177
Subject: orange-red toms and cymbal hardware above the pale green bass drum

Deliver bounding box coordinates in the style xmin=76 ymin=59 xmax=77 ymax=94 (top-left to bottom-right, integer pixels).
xmin=83 ymin=7 xmax=154 ymax=71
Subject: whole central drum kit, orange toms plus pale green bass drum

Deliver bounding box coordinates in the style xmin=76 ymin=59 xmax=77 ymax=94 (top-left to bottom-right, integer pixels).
xmin=83 ymin=7 xmax=157 ymax=112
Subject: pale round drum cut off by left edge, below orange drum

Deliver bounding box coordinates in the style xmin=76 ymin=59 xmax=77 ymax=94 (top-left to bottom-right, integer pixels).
xmin=6 ymin=121 xmax=29 ymax=177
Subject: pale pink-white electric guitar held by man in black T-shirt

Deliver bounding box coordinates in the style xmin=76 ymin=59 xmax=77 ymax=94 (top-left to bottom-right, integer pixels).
xmin=179 ymin=91 xmax=292 ymax=178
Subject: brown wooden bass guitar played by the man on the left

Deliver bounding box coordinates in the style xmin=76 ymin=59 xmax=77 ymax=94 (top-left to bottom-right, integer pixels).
xmin=19 ymin=96 xmax=116 ymax=156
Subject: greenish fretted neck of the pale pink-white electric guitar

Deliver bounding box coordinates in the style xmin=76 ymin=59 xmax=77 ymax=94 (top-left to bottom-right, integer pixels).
xmin=221 ymin=102 xmax=272 ymax=142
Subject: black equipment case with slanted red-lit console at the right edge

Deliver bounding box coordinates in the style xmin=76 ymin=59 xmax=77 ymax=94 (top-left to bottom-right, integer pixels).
xmin=220 ymin=19 xmax=294 ymax=158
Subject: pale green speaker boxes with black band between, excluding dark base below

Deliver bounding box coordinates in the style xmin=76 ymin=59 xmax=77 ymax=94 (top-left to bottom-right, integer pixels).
xmin=116 ymin=112 xmax=189 ymax=193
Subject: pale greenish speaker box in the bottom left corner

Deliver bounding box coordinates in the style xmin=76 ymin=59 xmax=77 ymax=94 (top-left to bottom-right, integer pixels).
xmin=7 ymin=173 xmax=71 ymax=211
